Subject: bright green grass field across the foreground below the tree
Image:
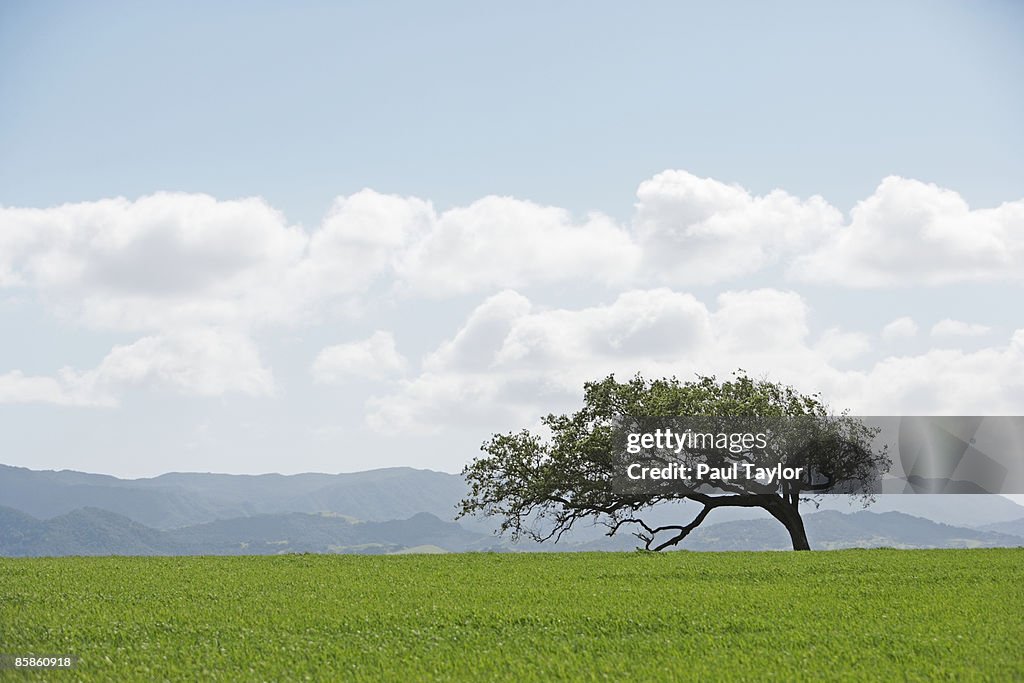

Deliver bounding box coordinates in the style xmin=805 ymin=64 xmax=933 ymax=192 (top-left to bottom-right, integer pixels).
xmin=0 ymin=550 xmax=1024 ymax=681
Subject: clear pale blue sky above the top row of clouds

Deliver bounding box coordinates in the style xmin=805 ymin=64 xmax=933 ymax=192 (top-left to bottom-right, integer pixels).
xmin=0 ymin=2 xmax=1024 ymax=224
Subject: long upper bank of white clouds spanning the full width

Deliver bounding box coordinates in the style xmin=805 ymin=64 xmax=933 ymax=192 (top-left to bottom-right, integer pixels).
xmin=0 ymin=176 xmax=1024 ymax=332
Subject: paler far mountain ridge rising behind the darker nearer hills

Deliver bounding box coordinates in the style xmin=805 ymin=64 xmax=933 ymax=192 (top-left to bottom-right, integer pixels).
xmin=0 ymin=465 xmax=1024 ymax=541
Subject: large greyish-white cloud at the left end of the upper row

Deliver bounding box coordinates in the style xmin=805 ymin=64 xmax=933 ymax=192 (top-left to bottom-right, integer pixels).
xmin=0 ymin=193 xmax=305 ymax=331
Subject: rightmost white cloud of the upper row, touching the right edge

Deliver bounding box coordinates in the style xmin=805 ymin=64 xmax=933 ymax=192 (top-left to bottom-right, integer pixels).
xmin=790 ymin=176 xmax=1024 ymax=287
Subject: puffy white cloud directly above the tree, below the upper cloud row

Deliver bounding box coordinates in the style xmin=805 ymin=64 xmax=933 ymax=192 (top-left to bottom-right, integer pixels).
xmin=369 ymin=288 xmax=823 ymax=431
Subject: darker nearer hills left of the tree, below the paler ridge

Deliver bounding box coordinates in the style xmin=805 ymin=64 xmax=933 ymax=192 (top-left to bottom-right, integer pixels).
xmin=0 ymin=508 xmax=488 ymax=557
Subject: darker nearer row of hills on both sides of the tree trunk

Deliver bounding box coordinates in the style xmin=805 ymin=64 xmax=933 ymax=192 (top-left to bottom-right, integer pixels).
xmin=0 ymin=508 xmax=1024 ymax=556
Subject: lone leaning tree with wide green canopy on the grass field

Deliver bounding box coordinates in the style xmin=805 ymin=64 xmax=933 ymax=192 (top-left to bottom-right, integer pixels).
xmin=459 ymin=371 xmax=888 ymax=550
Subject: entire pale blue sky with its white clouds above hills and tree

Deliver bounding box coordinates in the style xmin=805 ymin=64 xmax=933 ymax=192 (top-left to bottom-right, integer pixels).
xmin=0 ymin=0 xmax=1024 ymax=485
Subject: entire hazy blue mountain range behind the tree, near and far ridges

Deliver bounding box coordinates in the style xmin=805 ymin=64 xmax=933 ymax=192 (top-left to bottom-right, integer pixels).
xmin=0 ymin=465 xmax=1024 ymax=556
